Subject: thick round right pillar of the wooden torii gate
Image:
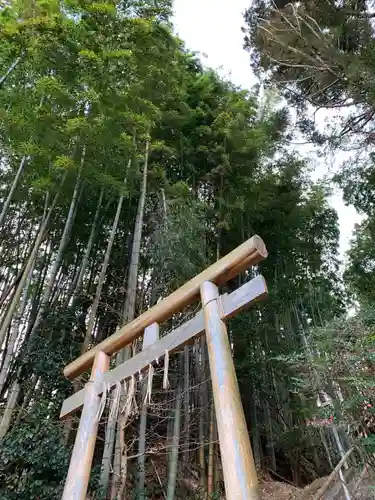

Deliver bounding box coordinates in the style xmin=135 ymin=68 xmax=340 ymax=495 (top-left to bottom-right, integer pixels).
xmin=200 ymin=281 xmax=260 ymax=500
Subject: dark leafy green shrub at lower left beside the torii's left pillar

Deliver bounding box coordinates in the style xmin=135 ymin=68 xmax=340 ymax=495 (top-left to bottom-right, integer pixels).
xmin=0 ymin=332 xmax=71 ymax=500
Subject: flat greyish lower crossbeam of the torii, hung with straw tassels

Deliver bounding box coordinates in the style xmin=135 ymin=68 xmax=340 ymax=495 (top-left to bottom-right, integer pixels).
xmin=60 ymin=276 xmax=267 ymax=419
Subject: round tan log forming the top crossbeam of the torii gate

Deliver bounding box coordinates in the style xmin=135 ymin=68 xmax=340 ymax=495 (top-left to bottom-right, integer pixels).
xmin=64 ymin=235 xmax=267 ymax=379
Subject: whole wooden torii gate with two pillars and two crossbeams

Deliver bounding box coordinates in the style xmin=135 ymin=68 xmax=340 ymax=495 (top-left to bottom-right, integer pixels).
xmin=60 ymin=236 xmax=267 ymax=500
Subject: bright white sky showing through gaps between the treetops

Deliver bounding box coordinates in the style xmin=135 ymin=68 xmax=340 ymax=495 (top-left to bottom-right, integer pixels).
xmin=174 ymin=0 xmax=361 ymax=257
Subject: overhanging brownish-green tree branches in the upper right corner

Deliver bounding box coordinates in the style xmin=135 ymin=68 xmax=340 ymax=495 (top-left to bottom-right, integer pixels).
xmin=245 ymin=0 xmax=375 ymax=142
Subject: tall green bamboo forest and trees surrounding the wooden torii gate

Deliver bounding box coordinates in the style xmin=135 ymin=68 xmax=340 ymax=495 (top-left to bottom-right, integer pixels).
xmin=0 ymin=0 xmax=375 ymax=500
